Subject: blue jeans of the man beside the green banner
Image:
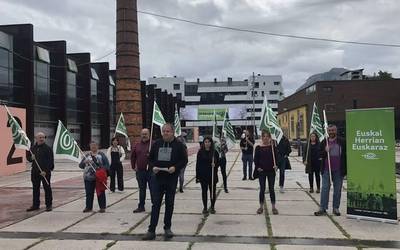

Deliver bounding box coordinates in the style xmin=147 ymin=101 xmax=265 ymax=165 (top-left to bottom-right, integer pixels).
xmin=320 ymin=170 xmax=343 ymax=210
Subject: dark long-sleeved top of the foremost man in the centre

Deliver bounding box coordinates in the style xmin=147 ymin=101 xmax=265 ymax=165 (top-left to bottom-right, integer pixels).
xmin=149 ymin=138 xmax=188 ymax=179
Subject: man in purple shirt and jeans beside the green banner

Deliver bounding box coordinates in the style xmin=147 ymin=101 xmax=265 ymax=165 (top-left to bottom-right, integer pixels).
xmin=314 ymin=125 xmax=347 ymax=216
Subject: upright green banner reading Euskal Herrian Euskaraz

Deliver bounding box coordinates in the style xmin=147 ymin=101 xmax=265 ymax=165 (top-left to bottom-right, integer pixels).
xmin=346 ymin=108 xmax=397 ymax=221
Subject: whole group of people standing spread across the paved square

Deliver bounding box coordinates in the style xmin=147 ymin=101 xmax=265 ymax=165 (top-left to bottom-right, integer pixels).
xmin=27 ymin=123 xmax=346 ymax=240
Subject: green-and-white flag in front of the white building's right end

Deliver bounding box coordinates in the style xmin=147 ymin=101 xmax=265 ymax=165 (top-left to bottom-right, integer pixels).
xmin=260 ymin=97 xmax=283 ymax=143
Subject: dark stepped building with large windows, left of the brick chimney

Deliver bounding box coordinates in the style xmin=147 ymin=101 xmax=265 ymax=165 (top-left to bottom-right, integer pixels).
xmin=0 ymin=24 xmax=115 ymax=149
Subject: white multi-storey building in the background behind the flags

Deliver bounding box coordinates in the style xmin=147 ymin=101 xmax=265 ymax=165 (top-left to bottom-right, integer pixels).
xmin=148 ymin=74 xmax=284 ymax=137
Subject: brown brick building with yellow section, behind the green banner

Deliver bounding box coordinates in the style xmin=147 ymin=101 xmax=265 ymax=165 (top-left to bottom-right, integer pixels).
xmin=278 ymin=70 xmax=400 ymax=140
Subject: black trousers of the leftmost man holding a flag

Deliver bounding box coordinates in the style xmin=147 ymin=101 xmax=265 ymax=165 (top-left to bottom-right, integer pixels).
xmin=31 ymin=171 xmax=53 ymax=208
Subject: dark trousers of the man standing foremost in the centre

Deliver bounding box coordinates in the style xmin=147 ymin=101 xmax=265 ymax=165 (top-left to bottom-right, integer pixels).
xmin=149 ymin=176 xmax=178 ymax=232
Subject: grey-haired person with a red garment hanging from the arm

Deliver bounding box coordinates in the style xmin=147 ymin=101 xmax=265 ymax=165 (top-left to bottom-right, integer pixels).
xmin=79 ymin=141 xmax=110 ymax=213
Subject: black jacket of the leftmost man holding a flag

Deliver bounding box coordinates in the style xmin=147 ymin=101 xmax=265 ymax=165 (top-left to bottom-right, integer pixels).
xmin=26 ymin=143 xmax=54 ymax=174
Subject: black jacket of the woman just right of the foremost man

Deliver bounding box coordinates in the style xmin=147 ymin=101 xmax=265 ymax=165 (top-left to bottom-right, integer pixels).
xmin=196 ymin=149 xmax=219 ymax=183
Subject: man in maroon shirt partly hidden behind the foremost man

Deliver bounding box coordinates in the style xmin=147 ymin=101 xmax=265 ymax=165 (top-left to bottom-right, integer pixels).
xmin=131 ymin=128 xmax=153 ymax=213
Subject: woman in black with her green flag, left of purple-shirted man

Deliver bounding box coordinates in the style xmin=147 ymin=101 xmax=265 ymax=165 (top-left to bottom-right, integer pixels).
xmin=303 ymin=102 xmax=325 ymax=193
